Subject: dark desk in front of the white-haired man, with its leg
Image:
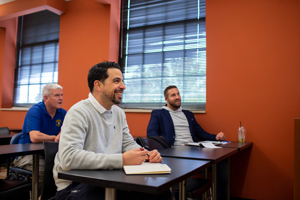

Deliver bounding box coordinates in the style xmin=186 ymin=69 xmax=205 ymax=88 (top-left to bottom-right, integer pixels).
xmin=0 ymin=143 xmax=44 ymax=200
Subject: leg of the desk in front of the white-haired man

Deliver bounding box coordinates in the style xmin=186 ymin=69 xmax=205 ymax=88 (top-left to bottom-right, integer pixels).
xmin=32 ymin=154 xmax=39 ymax=200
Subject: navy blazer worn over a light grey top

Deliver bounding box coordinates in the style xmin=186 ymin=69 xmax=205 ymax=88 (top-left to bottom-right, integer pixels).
xmin=147 ymin=109 xmax=216 ymax=146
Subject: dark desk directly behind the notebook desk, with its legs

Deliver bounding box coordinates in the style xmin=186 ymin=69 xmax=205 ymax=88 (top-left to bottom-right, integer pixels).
xmin=159 ymin=146 xmax=238 ymax=200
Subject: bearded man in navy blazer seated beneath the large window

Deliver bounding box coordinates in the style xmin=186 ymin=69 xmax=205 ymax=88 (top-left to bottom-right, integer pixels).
xmin=147 ymin=85 xmax=225 ymax=146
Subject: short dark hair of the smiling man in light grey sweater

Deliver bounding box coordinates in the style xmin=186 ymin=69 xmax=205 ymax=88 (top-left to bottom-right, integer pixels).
xmin=87 ymin=61 xmax=121 ymax=92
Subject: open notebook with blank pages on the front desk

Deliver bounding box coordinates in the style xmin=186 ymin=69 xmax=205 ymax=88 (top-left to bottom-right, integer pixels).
xmin=123 ymin=162 xmax=171 ymax=174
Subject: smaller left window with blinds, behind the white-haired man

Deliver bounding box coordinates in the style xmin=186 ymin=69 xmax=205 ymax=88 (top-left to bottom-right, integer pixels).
xmin=14 ymin=10 xmax=60 ymax=106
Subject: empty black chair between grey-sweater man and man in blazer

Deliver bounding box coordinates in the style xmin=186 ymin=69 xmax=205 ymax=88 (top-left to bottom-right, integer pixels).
xmin=137 ymin=136 xmax=212 ymax=199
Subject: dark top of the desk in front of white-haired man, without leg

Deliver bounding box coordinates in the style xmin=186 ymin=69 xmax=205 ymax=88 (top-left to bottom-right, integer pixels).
xmin=0 ymin=143 xmax=44 ymax=157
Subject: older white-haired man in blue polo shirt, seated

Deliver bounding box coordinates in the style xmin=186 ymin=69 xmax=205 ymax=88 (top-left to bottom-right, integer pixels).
xmin=14 ymin=84 xmax=67 ymax=192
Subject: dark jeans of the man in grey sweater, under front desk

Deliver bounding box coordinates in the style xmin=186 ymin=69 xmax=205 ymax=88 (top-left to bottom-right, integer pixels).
xmin=55 ymin=182 xmax=172 ymax=200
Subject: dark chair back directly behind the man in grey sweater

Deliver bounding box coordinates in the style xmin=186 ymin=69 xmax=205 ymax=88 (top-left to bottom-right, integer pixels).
xmin=41 ymin=142 xmax=58 ymax=200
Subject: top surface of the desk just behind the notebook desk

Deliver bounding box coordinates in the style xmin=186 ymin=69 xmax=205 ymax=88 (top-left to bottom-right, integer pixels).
xmin=159 ymin=146 xmax=238 ymax=163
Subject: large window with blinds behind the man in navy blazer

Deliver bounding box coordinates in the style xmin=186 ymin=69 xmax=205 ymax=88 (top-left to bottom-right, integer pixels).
xmin=119 ymin=0 xmax=206 ymax=111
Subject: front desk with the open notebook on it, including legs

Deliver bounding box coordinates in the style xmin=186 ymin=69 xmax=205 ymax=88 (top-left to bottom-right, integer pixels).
xmin=58 ymin=158 xmax=211 ymax=200
